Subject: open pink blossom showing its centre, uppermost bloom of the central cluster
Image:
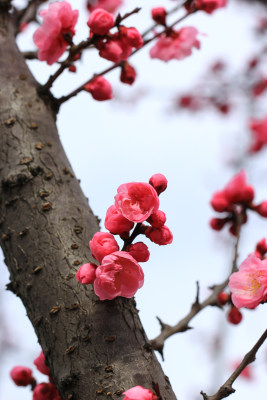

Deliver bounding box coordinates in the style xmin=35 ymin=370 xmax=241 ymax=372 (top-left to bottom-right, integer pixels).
xmin=115 ymin=182 xmax=159 ymax=222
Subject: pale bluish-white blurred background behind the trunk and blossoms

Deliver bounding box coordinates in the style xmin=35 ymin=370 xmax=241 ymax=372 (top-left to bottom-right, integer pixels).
xmin=0 ymin=0 xmax=267 ymax=400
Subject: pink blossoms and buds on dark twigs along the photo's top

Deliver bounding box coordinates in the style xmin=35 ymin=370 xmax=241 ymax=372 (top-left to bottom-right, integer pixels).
xmin=29 ymin=0 xmax=230 ymax=104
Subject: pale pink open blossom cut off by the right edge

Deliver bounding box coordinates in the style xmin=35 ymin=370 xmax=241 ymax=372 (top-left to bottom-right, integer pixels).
xmin=229 ymin=254 xmax=267 ymax=308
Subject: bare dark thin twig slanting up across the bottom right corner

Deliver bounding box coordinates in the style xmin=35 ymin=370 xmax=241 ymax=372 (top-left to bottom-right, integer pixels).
xmin=200 ymin=329 xmax=267 ymax=400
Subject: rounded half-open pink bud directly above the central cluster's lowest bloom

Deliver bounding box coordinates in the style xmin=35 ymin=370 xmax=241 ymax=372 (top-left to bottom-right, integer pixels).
xmin=89 ymin=232 xmax=119 ymax=263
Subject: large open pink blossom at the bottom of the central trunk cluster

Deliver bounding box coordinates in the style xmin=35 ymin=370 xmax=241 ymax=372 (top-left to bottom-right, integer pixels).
xmin=94 ymin=251 xmax=144 ymax=300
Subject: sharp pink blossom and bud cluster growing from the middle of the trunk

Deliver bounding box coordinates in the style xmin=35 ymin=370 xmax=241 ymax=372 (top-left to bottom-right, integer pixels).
xmin=76 ymin=174 xmax=173 ymax=300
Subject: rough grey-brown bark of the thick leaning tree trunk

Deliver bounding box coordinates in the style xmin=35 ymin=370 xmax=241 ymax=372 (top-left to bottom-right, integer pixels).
xmin=0 ymin=10 xmax=178 ymax=400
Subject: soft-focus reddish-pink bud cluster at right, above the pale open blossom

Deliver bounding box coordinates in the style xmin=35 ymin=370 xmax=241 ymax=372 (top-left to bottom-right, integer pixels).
xmin=210 ymin=170 xmax=267 ymax=235
